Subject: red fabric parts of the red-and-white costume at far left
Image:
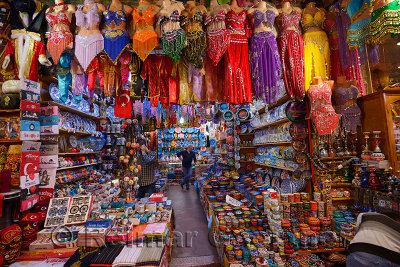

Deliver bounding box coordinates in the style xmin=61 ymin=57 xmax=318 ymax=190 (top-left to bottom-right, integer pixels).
xmin=4 ymin=39 xmax=46 ymax=82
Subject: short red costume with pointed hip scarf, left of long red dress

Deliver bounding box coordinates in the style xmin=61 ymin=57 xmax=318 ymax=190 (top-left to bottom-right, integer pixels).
xmin=204 ymin=10 xmax=231 ymax=66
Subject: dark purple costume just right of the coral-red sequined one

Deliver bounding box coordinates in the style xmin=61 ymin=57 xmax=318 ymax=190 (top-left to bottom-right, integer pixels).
xmin=332 ymin=85 xmax=361 ymax=133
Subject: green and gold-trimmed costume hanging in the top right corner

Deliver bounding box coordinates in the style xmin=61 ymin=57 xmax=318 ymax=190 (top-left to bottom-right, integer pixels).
xmin=370 ymin=0 xmax=400 ymax=43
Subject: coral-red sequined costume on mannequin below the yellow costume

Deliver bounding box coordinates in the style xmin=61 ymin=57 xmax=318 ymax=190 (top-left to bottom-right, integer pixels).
xmin=307 ymin=82 xmax=340 ymax=135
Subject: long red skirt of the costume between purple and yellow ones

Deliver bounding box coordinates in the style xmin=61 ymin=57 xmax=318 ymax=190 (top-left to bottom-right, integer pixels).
xmin=278 ymin=30 xmax=305 ymax=99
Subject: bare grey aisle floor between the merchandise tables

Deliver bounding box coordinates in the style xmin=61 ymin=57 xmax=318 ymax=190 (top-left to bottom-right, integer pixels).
xmin=167 ymin=184 xmax=220 ymax=267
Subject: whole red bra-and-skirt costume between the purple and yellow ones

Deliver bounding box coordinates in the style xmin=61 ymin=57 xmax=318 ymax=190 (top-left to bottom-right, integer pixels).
xmin=277 ymin=10 xmax=304 ymax=99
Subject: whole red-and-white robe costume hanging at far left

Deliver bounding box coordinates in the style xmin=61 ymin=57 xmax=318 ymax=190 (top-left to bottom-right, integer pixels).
xmin=4 ymin=30 xmax=46 ymax=82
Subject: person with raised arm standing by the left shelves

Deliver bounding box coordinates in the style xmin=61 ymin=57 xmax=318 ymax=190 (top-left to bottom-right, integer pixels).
xmin=136 ymin=139 xmax=158 ymax=198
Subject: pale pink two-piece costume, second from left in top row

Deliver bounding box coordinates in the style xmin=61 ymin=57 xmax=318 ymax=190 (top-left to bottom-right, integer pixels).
xmin=75 ymin=0 xmax=104 ymax=71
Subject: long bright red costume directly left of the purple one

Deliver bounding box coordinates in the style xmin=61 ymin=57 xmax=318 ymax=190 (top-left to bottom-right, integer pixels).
xmin=225 ymin=9 xmax=253 ymax=104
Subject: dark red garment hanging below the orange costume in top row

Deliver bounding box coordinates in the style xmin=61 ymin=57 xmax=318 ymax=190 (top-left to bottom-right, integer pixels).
xmin=140 ymin=55 xmax=173 ymax=107
